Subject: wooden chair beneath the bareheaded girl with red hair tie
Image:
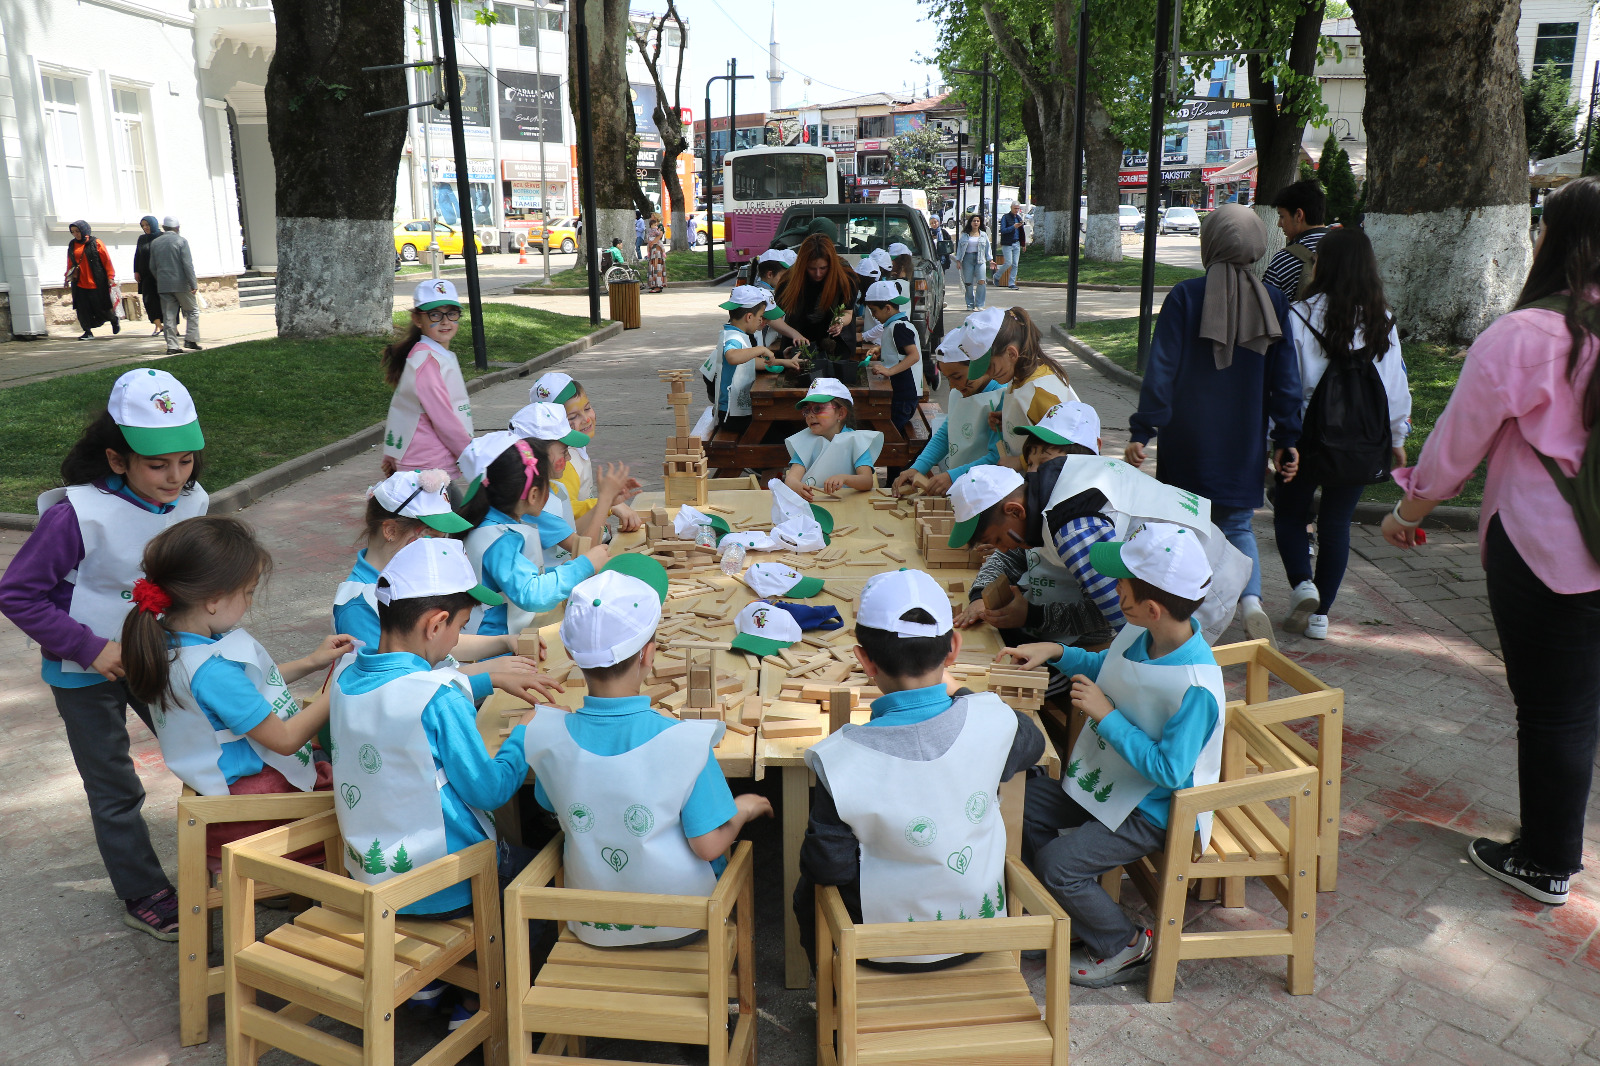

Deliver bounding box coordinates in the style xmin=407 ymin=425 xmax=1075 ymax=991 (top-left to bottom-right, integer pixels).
xmin=178 ymin=784 xmax=333 ymax=1047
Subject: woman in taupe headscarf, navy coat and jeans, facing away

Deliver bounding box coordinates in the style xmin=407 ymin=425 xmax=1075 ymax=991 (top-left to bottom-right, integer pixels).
xmin=1125 ymin=203 xmax=1301 ymax=640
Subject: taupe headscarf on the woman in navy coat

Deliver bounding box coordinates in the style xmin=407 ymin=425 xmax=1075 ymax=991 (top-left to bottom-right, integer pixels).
xmin=1200 ymin=203 xmax=1283 ymax=370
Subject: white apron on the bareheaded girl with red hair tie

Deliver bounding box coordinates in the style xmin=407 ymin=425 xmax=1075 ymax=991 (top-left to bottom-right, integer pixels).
xmin=150 ymin=629 xmax=317 ymax=795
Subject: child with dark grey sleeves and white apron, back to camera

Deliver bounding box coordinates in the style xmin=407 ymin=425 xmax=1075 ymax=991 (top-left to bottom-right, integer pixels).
xmin=794 ymin=570 xmax=1045 ymax=968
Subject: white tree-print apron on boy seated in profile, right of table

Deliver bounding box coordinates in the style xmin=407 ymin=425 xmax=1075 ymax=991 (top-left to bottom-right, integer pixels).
xmin=1061 ymin=626 xmax=1227 ymax=850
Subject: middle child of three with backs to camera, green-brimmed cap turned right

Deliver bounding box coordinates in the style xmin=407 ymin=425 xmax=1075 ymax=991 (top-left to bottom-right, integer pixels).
xmin=523 ymin=554 xmax=773 ymax=948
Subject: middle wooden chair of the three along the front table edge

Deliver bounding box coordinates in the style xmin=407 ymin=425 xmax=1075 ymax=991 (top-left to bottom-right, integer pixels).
xmin=506 ymin=834 xmax=755 ymax=1066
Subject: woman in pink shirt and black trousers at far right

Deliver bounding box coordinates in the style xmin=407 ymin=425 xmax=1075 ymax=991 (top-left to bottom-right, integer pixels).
xmin=1384 ymin=178 xmax=1600 ymax=904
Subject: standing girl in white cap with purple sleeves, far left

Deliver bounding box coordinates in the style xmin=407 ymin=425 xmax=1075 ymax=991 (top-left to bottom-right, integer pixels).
xmin=0 ymin=367 xmax=208 ymax=940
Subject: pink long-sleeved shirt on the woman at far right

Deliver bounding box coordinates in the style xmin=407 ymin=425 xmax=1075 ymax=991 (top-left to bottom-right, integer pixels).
xmin=1394 ymin=302 xmax=1600 ymax=594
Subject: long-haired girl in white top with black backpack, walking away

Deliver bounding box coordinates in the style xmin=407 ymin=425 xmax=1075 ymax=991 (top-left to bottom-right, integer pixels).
xmin=1272 ymin=227 xmax=1411 ymax=640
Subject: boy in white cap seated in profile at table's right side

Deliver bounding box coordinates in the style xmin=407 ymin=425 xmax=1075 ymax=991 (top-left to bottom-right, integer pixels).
xmin=995 ymin=522 xmax=1227 ymax=988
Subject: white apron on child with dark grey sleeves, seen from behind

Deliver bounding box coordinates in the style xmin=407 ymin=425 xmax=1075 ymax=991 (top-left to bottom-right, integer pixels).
xmin=805 ymin=693 xmax=1016 ymax=962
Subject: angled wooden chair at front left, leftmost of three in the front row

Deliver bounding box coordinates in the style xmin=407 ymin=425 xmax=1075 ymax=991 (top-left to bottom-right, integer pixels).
xmin=222 ymin=810 xmax=506 ymax=1066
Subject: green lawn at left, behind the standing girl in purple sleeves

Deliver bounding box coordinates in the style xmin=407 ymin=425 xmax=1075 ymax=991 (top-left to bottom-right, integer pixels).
xmin=0 ymin=304 xmax=592 ymax=514
